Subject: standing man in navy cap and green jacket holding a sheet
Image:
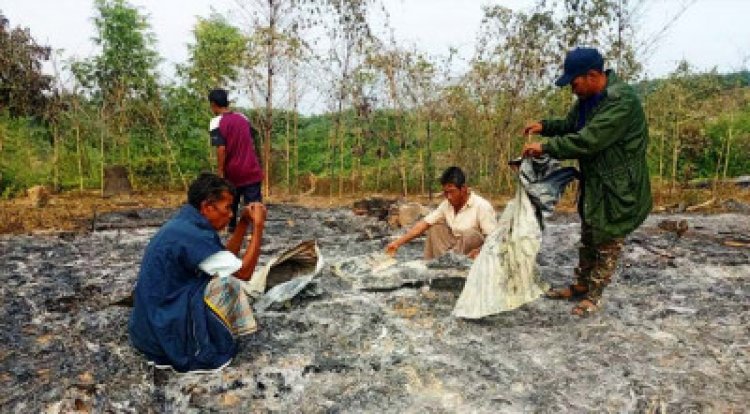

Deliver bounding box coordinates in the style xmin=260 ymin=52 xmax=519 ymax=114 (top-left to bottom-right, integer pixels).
xmin=523 ymin=48 xmax=652 ymax=316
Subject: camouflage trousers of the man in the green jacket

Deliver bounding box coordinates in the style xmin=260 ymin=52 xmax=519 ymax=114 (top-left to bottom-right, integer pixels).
xmin=575 ymin=224 xmax=624 ymax=305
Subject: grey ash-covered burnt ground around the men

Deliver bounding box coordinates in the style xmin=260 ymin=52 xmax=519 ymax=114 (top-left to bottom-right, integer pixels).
xmin=0 ymin=205 xmax=750 ymax=413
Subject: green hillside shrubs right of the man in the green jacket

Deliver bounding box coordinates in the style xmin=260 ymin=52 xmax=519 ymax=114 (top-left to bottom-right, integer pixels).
xmin=640 ymin=62 xmax=750 ymax=183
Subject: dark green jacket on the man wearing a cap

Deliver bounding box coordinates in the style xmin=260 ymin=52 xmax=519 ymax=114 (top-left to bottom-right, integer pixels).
xmin=541 ymin=71 xmax=652 ymax=244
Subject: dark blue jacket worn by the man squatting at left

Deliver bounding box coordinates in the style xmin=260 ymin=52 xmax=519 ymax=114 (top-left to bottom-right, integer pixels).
xmin=128 ymin=205 xmax=237 ymax=372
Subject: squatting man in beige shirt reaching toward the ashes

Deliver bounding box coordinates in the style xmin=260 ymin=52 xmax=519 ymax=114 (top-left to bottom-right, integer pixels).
xmin=386 ymin=167 xmax=497 ymax=260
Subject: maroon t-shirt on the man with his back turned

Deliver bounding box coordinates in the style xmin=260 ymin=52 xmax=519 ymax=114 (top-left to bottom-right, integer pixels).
xmin=209 ymin=112 xmax=263 ymax=187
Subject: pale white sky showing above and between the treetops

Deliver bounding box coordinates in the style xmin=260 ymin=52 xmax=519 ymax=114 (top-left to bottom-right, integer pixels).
xmin=0 ymin=0 xmax=750 ymax=110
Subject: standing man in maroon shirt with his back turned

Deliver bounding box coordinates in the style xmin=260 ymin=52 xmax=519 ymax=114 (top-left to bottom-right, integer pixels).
xmin=208 ymin=89 xmax=263 ymax=233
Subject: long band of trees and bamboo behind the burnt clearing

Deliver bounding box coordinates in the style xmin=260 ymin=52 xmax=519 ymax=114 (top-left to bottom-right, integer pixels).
xmin=0 ymin=0 xmax=750 ymax=197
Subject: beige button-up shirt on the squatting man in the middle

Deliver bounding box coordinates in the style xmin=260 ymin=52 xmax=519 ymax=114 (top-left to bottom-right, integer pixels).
xmin=424 ymin=191 xmax=497 ymax=237
